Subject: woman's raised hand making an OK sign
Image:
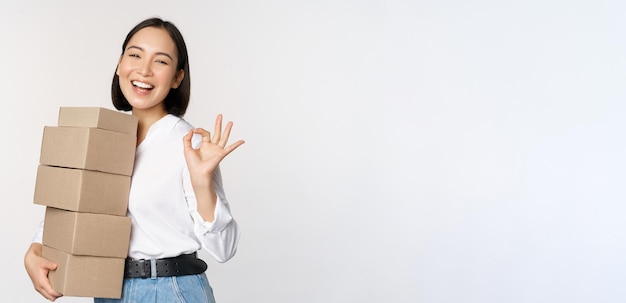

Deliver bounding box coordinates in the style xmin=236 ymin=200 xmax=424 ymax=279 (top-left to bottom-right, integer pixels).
xmin=183 ymin=114 xmax=244 ymax=182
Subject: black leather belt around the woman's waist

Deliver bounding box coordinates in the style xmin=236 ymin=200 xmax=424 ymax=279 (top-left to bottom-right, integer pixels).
xmin=124 ymin=253 xmax=207 ymax=279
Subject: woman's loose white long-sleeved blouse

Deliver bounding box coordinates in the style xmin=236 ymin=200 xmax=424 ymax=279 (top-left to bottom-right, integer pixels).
xmin=34 ymin=115 xmax=240 ymax=262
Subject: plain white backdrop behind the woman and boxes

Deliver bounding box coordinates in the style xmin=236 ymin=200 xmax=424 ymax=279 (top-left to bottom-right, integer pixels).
xmin=0 ymin=0 xmax=626 ymax=303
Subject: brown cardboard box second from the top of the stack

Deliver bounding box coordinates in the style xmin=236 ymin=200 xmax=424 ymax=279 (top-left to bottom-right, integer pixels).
xmin=39 ymin=126 xmax=137 ymax=176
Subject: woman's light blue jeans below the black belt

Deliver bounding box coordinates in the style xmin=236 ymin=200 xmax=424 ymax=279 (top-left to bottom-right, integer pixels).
xmin=94 ymin=273 xmax=215 ymax=303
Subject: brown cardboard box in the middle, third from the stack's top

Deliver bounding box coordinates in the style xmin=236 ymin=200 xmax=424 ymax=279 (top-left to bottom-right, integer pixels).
xmin=34 ymin=165 xmax=130 ymax=216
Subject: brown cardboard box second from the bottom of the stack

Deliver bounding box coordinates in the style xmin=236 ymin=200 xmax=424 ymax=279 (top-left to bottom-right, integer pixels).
xmin=43 ymin=207 xmax=131 ymax=258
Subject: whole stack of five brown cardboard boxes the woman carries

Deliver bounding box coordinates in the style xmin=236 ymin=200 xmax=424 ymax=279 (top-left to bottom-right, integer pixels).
xmin=34 ymin=107 xmax=137 ymax=298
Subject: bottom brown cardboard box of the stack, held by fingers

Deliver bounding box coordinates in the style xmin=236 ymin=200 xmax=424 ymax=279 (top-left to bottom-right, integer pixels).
xmin=42 ymin=245 xmax=125 ymax=299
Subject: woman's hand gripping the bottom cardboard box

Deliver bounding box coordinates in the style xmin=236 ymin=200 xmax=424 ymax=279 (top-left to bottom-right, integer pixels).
xmin=24 ymin=243 xmax=63 ymax=301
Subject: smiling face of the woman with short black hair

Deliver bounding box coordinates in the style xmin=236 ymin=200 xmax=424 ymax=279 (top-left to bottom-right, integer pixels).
xmin=116 ymin=27 xmax=184 ymax=113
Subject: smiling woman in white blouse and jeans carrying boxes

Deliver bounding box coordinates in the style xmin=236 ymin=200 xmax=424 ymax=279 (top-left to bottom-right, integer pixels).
xmin=24 ymin=18 xmax=244 ymax=303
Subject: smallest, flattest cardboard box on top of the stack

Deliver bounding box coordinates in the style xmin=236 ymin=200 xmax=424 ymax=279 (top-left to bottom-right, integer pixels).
xmin=58 ymin=107 xmax=138 ymax=136
